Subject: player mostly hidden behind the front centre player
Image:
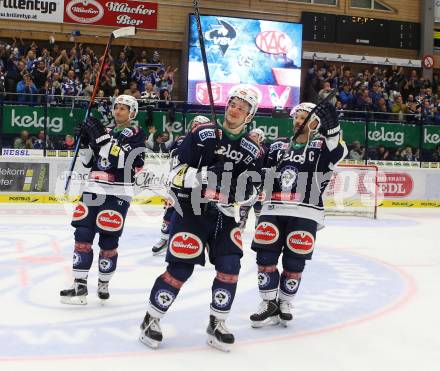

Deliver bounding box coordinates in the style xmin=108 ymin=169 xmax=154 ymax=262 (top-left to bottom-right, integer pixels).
xmin=151 ymin=115 xmax=210 ymax=255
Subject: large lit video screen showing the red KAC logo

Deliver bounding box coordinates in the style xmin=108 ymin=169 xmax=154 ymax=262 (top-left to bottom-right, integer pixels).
xmin=188 ymin=15 xmax=302 ymax=108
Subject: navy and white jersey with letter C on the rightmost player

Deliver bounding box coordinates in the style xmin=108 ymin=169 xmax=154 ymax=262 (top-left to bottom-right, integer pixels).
xmin=262 ymin=136 xmax=347 ymax=224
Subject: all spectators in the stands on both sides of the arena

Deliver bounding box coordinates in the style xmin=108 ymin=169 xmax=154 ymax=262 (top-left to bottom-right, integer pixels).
xmin=0 ymin=38 xmax=440 ymax=161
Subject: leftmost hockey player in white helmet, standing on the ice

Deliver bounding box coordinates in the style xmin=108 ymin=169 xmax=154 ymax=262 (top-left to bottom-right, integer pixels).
xmin=60 ymin=95 xmax=146 ymax=305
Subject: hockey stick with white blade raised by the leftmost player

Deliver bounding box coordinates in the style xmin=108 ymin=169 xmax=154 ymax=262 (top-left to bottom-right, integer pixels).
xmin=64 ymin=27 xmax=136 ymax=194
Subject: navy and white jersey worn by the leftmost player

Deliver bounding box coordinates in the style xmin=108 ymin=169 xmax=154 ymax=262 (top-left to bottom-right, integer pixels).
xmin=81 ymin=126 xmax=146 ymax=195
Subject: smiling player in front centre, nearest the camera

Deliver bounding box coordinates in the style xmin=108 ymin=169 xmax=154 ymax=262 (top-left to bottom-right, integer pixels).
xmin=140 ymin=87 xmax=261 ymax=351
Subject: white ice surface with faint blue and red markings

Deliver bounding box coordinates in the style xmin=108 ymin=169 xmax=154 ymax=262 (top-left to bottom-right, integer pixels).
xmin=0 ymin=204 xmax=440 ymax=371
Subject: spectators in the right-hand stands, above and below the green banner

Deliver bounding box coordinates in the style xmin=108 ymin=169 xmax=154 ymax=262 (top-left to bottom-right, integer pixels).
xmin=304 ymin=61 xmax=440 ymax=161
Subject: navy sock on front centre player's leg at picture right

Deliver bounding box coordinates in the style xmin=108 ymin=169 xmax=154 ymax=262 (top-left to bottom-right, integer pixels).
xmin=211 ymin=272 xmax=238 ymax=320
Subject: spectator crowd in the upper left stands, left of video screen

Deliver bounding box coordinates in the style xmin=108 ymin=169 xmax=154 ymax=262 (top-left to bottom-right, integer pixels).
xmin=0 ymin=38 xmax=177 ymax=105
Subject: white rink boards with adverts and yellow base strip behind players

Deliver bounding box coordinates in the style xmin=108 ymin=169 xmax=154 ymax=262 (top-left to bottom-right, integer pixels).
xmin=0 ymin=154 xmax=440 ymax=208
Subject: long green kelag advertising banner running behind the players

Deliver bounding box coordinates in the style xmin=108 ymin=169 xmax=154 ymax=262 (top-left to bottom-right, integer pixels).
xmin=3 ymin=105 xmax=440 ymax=150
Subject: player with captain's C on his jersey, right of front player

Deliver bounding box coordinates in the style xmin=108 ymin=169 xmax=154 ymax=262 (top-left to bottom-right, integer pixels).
xmin=250 ymin=103 xmax=347 ymax=327
